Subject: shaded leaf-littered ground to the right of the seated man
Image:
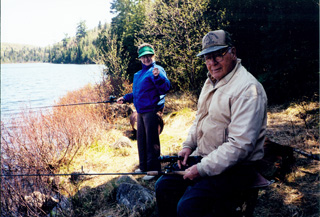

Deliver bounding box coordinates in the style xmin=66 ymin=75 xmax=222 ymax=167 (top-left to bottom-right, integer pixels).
xmin=254 ymin=103 xmax=320 ymax=217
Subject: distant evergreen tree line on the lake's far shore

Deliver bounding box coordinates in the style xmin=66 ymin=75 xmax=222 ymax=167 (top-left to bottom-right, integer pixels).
xmin=1 ymin=21 xmax=108 ymax=64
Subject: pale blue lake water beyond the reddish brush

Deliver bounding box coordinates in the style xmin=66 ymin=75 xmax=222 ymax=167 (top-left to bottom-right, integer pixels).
xmin=1 ymin=63 xmax=104 ymax=122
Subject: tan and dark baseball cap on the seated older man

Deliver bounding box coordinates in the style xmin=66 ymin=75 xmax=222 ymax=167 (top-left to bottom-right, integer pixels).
xmin=197 ymin=30 xmax=232 ymax=56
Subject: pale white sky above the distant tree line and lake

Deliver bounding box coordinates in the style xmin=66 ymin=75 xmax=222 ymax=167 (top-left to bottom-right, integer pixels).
xmin=1 ymin=0 xmax=113 ymax=47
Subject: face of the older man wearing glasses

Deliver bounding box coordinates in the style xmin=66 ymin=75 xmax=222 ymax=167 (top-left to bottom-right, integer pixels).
xmin=204 ymin=47 xmax=237 ymax=80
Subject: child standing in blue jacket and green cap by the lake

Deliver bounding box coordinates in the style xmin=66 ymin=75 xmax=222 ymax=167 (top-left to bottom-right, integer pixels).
xmin=117 ymin=43 xmax=170 ymax=180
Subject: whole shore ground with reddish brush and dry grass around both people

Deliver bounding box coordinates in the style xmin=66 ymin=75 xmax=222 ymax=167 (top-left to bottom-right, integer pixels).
xmin=1 ymin=82 xmax=320 ymax=217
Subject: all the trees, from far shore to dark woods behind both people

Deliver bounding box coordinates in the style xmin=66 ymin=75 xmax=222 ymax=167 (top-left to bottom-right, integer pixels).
xmin=1 ymin=0 xmax=319 ymax=103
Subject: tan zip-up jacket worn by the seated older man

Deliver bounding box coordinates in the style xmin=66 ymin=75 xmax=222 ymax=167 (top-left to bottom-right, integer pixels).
xmin=183 ymin=59 xmax=267 ymax=176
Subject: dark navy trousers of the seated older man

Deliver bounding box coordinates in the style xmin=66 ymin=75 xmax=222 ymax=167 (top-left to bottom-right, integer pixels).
xmin=155 ymin=166 xmax=256 ymax=217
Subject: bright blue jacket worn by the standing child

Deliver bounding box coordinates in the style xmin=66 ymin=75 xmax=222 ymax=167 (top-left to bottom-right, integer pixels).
xmin=123 ymin=62 xmax=170 ymax=113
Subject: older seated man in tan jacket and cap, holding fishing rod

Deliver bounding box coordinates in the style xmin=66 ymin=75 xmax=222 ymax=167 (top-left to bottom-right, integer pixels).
xmin=155 ymin=30 xmax=267 ymax=217
